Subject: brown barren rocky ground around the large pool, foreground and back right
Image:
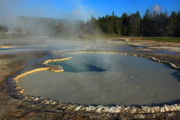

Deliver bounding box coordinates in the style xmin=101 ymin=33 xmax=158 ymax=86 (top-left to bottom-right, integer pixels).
xmin=0 ymin=39 xmax=180 ymax=120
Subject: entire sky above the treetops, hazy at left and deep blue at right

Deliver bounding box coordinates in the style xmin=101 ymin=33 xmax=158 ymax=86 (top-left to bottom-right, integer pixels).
xmin=0 ymin=0 xmax=180 ymax=19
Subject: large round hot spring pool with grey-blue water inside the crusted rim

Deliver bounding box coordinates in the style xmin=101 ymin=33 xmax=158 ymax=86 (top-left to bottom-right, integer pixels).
xmin=19 ymin=54 xmax=180 ymax=105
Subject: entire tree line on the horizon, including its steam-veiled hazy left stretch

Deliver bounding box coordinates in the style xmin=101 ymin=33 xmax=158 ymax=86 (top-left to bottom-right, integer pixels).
xmin=0 ymin=10 xmax=180 ymax=37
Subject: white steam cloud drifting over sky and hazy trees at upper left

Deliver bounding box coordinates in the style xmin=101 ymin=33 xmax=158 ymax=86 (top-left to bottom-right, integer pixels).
xmin=0 ymin=0 xmax=97 ymax=35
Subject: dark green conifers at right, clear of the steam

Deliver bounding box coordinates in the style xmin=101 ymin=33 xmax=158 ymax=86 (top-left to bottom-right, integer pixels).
xmin=86 ymin=10 xmax=180 ymax=37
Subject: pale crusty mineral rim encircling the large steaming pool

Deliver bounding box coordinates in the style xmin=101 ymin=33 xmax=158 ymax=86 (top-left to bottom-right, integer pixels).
xmin=6 ymin=51 xmax=180 ymax=113
